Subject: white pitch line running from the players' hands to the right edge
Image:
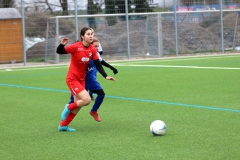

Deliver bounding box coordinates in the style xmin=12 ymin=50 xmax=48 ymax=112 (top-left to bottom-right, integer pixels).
xmin=114 ymin=64 xmax=240 ymax=70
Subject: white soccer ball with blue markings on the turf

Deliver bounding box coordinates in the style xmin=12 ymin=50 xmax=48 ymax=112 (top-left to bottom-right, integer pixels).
xmin=150 ymin=120 xmax=167 ymax=136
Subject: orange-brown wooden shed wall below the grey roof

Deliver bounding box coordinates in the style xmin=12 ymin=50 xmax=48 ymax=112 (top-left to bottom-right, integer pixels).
xmin=0 ymin=19 xmax=23 ymax=63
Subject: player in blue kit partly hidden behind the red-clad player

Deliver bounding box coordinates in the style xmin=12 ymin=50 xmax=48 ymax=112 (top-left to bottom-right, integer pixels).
xmin=69 ymin=37 xmax=118 ymax=122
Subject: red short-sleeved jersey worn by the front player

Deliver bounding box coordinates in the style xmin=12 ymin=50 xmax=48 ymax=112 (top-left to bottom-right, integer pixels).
xmin=65 ymin=42 xmax=99 ymax=81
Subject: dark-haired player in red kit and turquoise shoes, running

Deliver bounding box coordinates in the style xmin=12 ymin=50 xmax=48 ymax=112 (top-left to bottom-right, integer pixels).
xmin=56 ymin=28 xmax=115 ymax=132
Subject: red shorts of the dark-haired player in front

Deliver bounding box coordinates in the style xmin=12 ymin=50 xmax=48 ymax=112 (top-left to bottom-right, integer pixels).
xmin=66 ymin=73 xmax=85 ymax=95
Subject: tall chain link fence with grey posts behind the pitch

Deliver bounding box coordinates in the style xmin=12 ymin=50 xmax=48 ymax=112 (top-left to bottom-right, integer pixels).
xmin=0 ymin=0 xmax=240 ymax=65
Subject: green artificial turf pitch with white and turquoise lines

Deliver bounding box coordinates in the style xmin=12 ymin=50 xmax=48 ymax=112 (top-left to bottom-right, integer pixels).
xmin=0 ymin=55 xmax=240 ymax=160
